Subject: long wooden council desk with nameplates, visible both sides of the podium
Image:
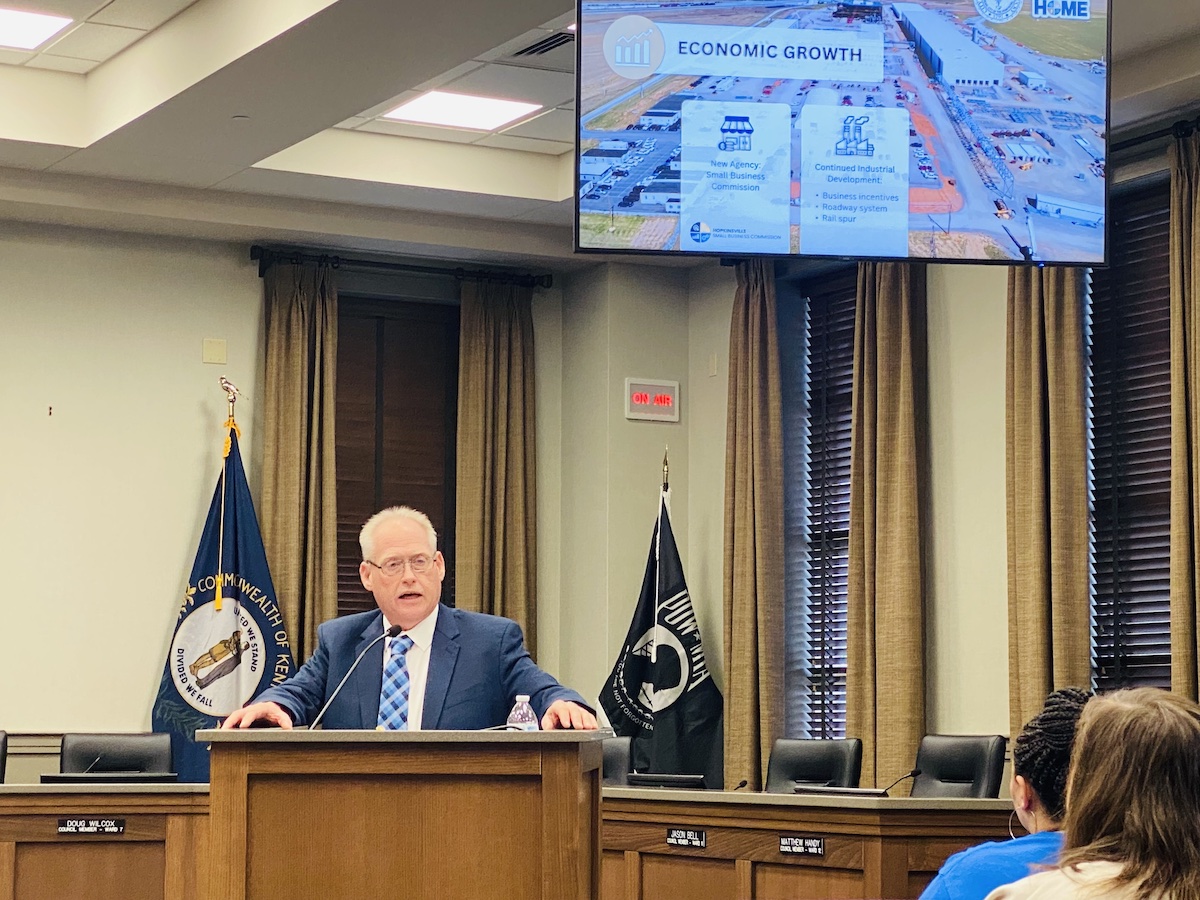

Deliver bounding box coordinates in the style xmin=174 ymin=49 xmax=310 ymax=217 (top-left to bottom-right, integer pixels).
xmin=0 ymin=785 xmax=1012 ymax=900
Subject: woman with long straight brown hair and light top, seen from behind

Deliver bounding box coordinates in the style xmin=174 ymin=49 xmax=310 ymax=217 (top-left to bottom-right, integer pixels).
xmin=988 ymin=688 xmax=1200 ymax=900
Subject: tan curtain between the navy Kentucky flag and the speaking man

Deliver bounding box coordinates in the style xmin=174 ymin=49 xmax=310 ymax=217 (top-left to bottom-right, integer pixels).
xmin=263 ymin=263 xmax=337 ymax=664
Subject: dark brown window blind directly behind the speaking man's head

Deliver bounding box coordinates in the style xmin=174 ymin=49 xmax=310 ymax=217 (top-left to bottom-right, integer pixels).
xmin=335 ymin=298 xmax=458 ymax=616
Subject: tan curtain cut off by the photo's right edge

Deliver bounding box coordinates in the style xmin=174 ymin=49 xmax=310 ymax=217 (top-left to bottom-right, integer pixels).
xmin=1170 ymin=134 xmax=1200 ymax=700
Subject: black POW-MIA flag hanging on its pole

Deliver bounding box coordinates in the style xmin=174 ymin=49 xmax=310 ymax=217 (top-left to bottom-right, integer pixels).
xmin=600 ymin=491 xmax=724 ymax=787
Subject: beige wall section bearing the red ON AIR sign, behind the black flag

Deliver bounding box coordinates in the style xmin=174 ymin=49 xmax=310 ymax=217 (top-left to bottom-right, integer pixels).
xmin=560 ymin=264 xmax=690 ymax=697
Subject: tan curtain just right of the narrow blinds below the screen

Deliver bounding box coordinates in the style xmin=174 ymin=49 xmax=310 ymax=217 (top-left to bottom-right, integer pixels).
xmin=846 ymin=263 xmax=929 ymax=786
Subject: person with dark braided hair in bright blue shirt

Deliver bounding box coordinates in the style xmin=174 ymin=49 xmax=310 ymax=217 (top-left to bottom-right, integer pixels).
xmin=920 ymin=688 xmax=1092 ymax=900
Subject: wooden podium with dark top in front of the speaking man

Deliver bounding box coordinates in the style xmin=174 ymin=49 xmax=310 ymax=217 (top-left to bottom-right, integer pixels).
xmin=204 ymin=728 xmax=604 ymax=900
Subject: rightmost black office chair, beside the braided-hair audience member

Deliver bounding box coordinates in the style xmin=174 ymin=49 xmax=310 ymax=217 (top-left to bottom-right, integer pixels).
xmin=910 ymin=734 xmax=1008 ymax=798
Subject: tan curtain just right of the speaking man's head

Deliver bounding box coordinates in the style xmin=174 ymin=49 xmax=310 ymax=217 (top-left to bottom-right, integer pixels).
xmin=455 ymin=281 xmax=538 ymax=656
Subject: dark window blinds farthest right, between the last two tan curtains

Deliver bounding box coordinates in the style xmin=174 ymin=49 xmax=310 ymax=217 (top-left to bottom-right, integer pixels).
xmin=1088 ymin=185 xmax=1171 ymax=690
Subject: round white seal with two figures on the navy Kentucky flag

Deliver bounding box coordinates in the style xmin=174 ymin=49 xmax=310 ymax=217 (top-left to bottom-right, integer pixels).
xmin=170 ymin=601 xmax=266 ymax=718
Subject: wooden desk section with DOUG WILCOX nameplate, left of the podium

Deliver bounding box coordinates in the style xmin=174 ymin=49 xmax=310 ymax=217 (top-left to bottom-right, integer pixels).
xmin=0 ymin=785 xmax=209 ymax=900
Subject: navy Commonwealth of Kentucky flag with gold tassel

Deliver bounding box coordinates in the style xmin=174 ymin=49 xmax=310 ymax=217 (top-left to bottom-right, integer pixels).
xmin=154 ymin=429 xmax=294 ymax=781
